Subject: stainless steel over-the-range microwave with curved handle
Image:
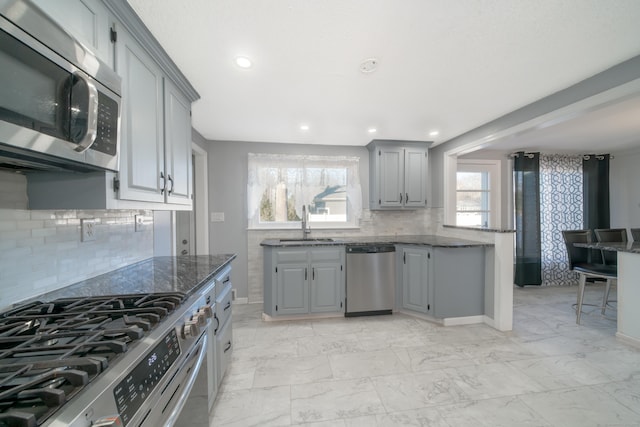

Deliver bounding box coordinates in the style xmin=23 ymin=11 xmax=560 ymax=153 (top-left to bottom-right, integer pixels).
xmin=0 ymin=0 xmax=121 ymax=172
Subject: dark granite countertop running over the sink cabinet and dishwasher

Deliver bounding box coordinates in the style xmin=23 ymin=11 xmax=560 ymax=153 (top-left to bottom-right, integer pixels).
xmin=260 ymin=234 xmax=493 ymax=248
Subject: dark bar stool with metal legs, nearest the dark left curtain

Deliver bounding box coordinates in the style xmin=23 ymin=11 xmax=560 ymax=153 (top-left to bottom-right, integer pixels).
xmin=562 ymin=230 xmax=618 ymax=324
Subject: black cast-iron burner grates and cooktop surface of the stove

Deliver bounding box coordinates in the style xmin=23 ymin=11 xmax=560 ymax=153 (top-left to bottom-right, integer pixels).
xmin=0 ymin=293 xmax=186 ymax=427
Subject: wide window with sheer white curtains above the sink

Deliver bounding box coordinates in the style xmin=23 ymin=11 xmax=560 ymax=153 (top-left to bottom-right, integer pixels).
xmin=247 ymin=153 xmax=362 ymax=228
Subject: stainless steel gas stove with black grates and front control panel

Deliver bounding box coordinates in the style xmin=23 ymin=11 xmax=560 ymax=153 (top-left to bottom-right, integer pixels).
xmin=0 ymin=292 xmax=212 ymax=427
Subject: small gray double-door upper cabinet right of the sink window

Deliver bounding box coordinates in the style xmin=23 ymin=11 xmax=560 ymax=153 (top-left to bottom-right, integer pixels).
xmin=367 ymin=140 xmax=430 ymax=209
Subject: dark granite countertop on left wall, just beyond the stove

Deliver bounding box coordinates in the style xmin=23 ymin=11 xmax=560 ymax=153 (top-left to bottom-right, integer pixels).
xmin=20 ymin=254 xmax=236 ymax=304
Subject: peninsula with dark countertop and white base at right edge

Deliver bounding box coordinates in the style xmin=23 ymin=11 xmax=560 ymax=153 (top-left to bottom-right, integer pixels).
xmin=574 ymin=242 xmax=640 ymax=346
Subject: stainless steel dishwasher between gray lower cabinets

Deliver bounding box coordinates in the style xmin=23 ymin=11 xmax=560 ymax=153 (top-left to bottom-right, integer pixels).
xmin=344 ymin=244 xmax=396 ymax=317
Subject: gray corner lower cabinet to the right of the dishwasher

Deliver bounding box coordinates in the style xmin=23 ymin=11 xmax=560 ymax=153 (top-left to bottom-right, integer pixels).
xmin=398 ymin=246 xmax=485 ymax=319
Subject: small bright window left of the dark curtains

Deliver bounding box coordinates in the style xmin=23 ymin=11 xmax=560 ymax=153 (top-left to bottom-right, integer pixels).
xmin=456 ymin=169 xmax=491 ymax=227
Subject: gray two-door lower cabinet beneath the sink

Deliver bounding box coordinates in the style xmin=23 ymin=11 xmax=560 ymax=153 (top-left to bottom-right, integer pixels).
xmin=264 ymin=246 xmax=345 ymax=316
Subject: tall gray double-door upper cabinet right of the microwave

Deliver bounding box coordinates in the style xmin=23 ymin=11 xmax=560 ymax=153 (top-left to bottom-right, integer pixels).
xmin=116 ymin=25 xmax=193 ymax=206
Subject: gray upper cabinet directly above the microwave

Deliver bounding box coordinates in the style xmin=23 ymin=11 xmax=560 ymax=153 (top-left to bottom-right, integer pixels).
xmin=33 ymin=0 xmax=113 ymax=68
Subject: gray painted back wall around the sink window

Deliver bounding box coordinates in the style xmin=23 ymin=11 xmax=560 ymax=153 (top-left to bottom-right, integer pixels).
xmin=205 ymin=138 xmax=369 ymax=297
